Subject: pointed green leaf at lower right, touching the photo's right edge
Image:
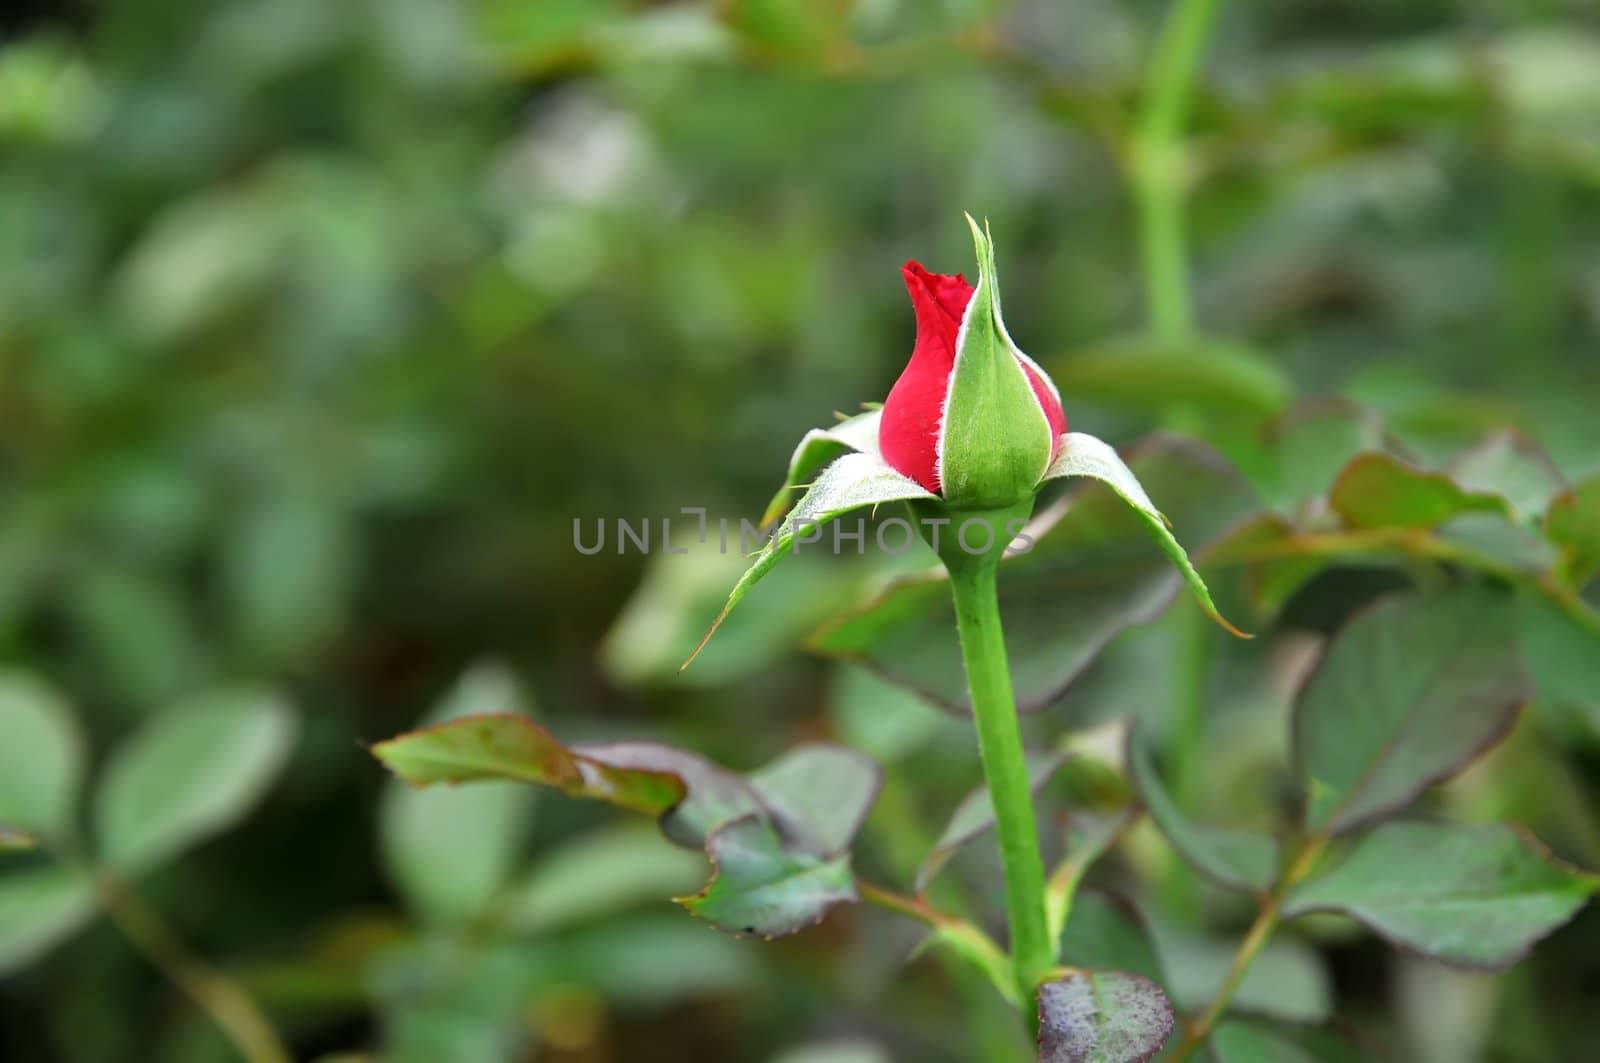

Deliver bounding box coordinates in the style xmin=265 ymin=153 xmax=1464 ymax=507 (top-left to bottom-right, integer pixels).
xmin=1283 ymin=823 xmax=1600 ymax=970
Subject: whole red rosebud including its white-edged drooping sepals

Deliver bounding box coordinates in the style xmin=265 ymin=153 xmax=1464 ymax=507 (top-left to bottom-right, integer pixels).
xmin=683 ymin=216 xmax=1250 ymax=668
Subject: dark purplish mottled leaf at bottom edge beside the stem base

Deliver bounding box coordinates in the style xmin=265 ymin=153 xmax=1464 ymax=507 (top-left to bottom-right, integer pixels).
xmin=1038 ymin=970 xmax=1173 ymax=1063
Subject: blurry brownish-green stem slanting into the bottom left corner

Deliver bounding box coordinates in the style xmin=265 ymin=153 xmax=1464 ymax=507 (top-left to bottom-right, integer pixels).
xmin=94 ymin=874 xmax=293 ymax=1063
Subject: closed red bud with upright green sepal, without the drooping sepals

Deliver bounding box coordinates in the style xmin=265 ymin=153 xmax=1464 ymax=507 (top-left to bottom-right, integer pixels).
xmin=878 ymin=218 xmax=1067 ymax=509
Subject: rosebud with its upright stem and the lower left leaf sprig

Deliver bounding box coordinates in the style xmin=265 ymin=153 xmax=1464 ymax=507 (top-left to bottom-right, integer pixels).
xmin=374 ymin=216 xmax=1273 ymax=1050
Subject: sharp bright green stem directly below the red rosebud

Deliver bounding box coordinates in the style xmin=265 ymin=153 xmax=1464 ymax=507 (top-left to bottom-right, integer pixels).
xmin=942 ymin=551 xmax=1056 ymax=1001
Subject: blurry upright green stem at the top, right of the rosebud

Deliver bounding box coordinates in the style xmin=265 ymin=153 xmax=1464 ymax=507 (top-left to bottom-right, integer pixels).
xmin=1133 ymin=0 xmax=1219 ymax=344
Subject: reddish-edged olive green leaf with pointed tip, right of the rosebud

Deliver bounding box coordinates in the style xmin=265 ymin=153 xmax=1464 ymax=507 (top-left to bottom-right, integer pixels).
xmin=1328 ymin=453 xmax=1510 ymax=528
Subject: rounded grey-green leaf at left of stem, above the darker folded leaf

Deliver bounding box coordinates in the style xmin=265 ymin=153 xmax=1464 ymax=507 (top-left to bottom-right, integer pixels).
xmin=749 ymin=744 xmax=883 ymax=856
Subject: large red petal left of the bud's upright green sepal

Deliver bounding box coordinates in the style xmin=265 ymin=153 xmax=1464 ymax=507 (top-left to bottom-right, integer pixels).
xmin=878 ymin=263 xmax=972 ymax=493
